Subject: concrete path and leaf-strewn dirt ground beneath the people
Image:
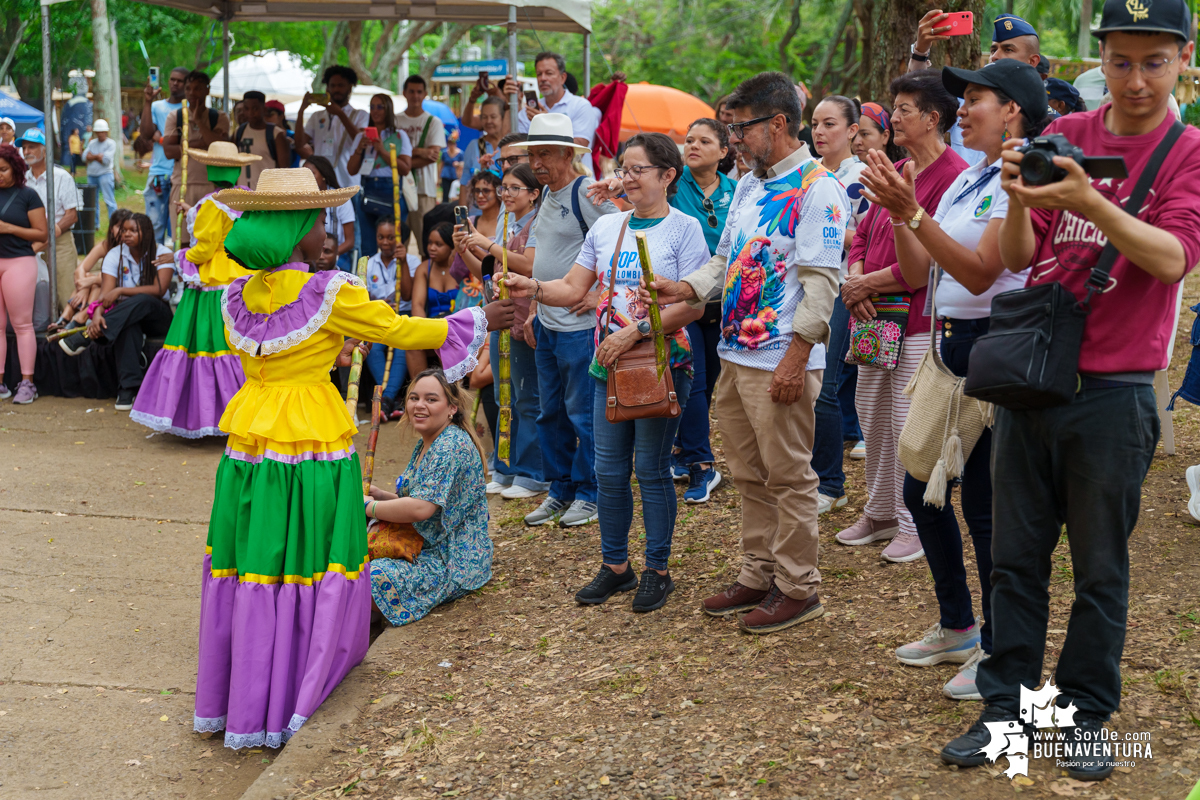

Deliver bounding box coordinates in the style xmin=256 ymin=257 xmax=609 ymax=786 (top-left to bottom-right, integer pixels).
xmin=0 ymin=297 xmax=1200 ymax=800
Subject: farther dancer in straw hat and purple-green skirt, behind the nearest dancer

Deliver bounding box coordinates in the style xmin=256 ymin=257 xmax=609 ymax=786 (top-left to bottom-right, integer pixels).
xmin=130 ymin=142 xmax=263 ymax=439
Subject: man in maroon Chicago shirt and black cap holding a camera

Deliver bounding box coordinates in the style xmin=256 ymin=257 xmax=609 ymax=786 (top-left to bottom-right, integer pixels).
xmin=942 ymin=0 xmax=1200 ymax=781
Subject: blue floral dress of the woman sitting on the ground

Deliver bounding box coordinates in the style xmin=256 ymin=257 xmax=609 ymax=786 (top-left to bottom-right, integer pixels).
xmin=371 ymin=425 xmax=492 ymax=625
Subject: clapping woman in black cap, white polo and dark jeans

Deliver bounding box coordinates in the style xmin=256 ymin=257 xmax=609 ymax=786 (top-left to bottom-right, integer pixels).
xmin=862 ymin=59 xmax=1048 ymax=700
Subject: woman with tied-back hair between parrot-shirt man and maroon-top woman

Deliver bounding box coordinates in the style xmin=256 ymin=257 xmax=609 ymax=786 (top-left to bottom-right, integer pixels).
xmin=812 ymin=95 xmax=871 ymax=513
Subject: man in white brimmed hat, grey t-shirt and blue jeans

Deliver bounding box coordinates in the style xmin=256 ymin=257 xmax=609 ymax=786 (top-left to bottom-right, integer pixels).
xmin=512 ymin=114 xmax=617 ymax=527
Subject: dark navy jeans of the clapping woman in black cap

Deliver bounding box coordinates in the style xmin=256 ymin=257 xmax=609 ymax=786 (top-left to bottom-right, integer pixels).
xmin=904 ymin=317 xmax=992 ymax=655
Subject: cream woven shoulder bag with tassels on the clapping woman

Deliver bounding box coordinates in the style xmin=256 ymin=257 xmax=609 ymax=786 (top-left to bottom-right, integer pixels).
xmin=900 ymin=267 xmax=992 ymax=509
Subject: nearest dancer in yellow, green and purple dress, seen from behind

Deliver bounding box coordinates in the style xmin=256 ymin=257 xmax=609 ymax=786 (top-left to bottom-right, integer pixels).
xmin=194 ymin=169 xmax=514 ymax=748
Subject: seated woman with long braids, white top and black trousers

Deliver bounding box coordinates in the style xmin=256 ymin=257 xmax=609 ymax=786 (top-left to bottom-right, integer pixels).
xmin=59 ymin=213 xmax=175 ymax=411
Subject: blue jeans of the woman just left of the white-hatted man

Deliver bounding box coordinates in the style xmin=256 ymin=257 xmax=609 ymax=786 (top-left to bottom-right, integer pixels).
xmin=487 ymin=331 xmax=550 ymax=492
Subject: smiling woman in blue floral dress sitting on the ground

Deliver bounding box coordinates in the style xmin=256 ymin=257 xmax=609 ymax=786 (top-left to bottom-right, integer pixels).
xmin=364 ymin=369 xmax=492 ymax=625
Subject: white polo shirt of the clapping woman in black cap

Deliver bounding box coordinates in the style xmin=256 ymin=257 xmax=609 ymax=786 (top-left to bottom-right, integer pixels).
xmin=934 ymin=155 xmax=1030 ymax=319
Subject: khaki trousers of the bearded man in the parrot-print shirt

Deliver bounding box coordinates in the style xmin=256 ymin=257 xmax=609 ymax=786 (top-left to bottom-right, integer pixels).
xmin=713 ymin=359 xmax=824 ymax=600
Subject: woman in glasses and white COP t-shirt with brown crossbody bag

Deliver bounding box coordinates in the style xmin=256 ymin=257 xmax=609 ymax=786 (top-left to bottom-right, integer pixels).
xmin=508 ymin=133 xmax=708 ymax=612
